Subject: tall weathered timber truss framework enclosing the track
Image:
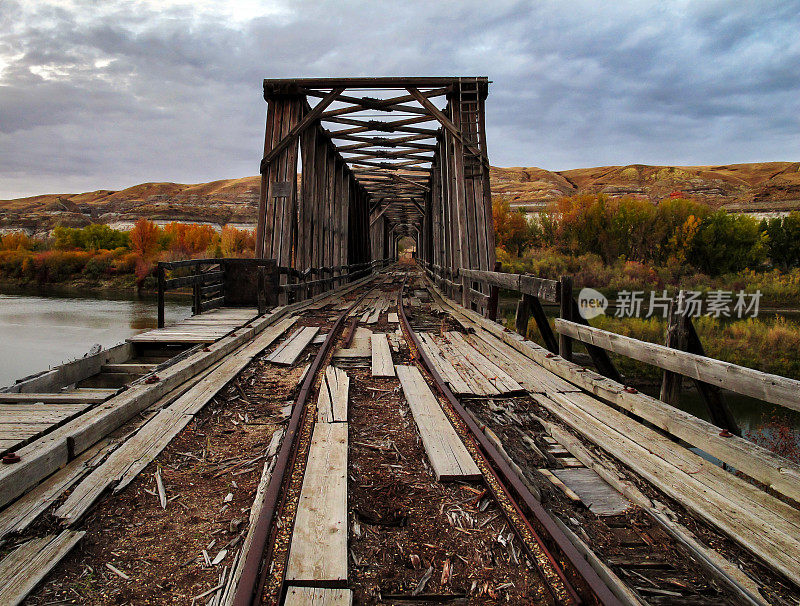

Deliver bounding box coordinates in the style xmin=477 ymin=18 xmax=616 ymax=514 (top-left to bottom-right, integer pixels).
xmin=256 ymin=77 xmax=495 ymax=307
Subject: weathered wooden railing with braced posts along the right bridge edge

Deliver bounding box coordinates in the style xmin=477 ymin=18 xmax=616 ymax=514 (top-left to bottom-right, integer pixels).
xmin=422 ymin=262 xmax=800 ymax=502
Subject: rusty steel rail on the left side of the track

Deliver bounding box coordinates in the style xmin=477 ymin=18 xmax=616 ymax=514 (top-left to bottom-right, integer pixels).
xmin=232 ymin=276 xmax=382 ymax=606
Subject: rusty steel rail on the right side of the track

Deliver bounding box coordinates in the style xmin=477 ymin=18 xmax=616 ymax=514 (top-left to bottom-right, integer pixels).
xmin=397 ymin=276 xmax=622 ymax=606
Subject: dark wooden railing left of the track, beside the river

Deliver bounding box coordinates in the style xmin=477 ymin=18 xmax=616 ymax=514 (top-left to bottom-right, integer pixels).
xmin=156 ymin=258 xmax=391 ymax=328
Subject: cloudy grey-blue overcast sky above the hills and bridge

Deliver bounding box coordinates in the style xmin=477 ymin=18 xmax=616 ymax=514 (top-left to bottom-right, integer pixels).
xmin=0 ymin=0 xmax=800 ymax=199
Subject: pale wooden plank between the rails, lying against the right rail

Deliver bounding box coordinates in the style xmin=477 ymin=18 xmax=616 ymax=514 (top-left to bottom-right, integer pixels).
xmin=397 ymin=366 xmax=481 ymax=481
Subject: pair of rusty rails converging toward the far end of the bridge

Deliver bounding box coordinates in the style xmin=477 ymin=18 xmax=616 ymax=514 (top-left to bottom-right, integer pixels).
xmin=227 ymin=277 xmax=619 ymax=606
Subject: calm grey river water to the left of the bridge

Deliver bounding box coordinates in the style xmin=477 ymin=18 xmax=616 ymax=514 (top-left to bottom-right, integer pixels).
xmin=0 ymin=289 xmax=191 ymax=387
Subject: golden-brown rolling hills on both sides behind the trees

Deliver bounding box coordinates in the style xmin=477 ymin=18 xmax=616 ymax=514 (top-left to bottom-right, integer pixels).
xmin=0 ymin=162 xmax=800 ymax=233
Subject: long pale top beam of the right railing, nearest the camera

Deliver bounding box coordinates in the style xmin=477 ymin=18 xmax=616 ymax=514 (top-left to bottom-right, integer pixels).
xmin=555 ymin=319 xmax=800 ymax=411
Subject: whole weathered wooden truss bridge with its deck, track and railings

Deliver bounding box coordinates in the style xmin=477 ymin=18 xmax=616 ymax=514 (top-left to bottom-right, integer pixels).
xmin=0 ymin=78 xmax=800 ymax=606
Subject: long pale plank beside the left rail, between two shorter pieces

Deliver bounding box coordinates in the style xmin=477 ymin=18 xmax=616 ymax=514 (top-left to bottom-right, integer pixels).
xmin=286 ymin=423 xmax=348 ymax=587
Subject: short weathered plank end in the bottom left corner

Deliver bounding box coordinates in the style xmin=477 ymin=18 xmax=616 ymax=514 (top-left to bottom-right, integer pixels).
xmin=0 ymin=530 xmax=86 ymax=606
